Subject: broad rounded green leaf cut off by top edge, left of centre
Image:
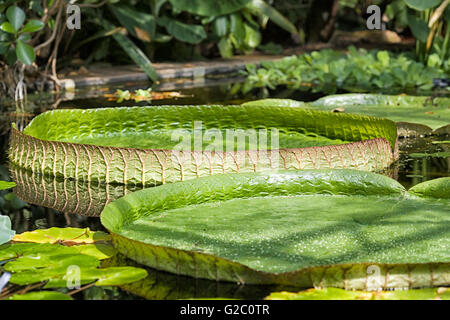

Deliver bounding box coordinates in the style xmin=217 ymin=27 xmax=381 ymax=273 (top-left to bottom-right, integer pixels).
xmin=169 ymin=0 xmax=251 ymax=16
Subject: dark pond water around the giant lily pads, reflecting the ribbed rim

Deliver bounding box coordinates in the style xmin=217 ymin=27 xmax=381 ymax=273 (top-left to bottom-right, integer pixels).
xmin=0 ymin=79 xmax=450 ymax=299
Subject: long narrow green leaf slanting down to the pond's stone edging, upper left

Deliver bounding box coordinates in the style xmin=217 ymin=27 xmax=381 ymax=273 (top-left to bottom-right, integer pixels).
xmin=102 ymin=20 xmax=158 ymax=81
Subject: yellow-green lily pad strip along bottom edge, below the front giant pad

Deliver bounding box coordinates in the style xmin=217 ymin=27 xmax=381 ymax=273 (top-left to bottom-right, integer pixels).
xmin=266 ymin=288 xmax=450 ymax=300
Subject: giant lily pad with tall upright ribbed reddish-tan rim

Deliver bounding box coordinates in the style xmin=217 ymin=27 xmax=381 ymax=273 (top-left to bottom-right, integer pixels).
xmin=9 ymin=105 xmax=397 ymax=186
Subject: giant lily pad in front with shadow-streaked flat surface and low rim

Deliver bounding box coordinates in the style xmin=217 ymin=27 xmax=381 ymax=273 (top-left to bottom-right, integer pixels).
xmin=101 ymin=169 xmax=450 ymax=289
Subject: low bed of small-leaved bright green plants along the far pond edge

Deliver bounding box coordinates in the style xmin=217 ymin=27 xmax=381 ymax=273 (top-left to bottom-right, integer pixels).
xmin=242 ymin=47 xmax=450 ymax=93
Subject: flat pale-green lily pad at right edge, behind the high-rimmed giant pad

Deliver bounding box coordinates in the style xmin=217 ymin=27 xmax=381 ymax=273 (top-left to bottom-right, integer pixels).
xmin=309 ymin=94 xmax=450 ymax=130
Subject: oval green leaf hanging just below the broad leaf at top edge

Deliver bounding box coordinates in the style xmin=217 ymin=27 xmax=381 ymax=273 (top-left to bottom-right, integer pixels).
xmin=158 ymin=17 xmax=206 ymax=44
